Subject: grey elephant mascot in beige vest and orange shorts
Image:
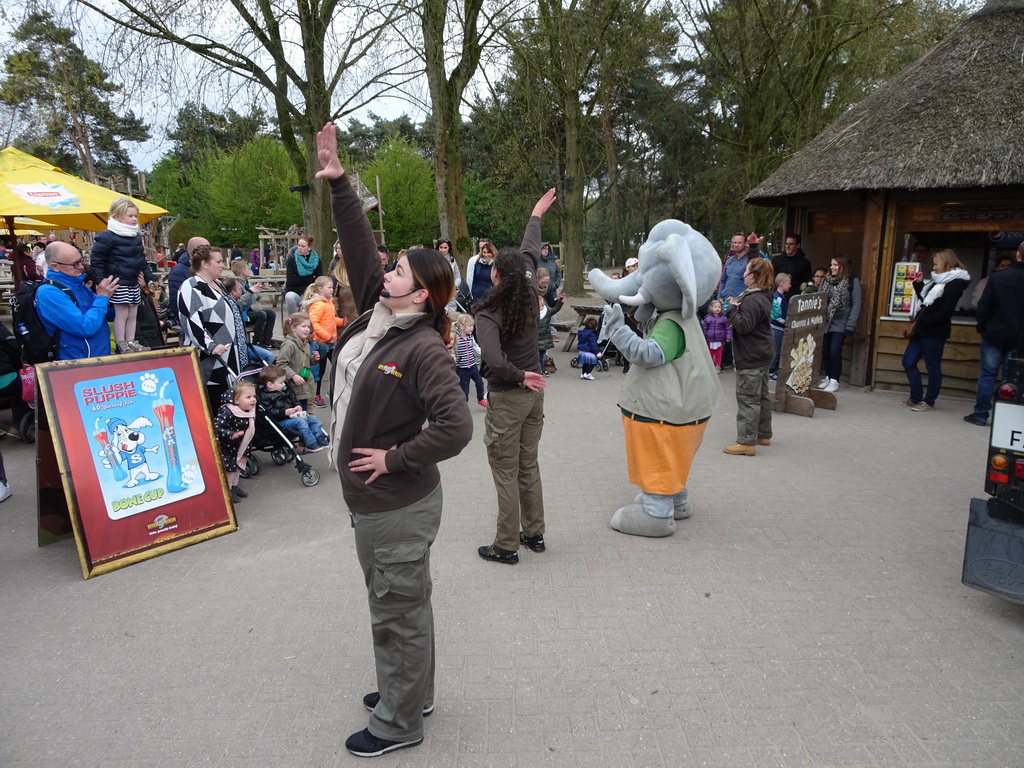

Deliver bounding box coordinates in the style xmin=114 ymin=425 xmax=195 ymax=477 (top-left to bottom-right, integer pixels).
xmin=590 ymin=219 xmax=724 ymax=537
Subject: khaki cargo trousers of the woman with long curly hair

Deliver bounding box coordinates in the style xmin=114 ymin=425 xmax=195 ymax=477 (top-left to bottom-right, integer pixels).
xmin=483 ymin=388 xmax=544 ymax=551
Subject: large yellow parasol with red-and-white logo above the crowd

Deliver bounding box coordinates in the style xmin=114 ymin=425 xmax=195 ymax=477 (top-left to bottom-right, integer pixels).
xmin=0 ymin=146 xmax=167 ymax=232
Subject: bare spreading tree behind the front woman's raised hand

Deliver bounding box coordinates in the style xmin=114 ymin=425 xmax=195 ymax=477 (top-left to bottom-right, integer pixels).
xmin=74 ymin=0 xmax=417 ymax=256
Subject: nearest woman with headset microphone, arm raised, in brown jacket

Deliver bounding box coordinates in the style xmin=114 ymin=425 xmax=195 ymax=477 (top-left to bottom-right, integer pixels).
xmin=316 ymin=123 xmax=471 ymax=757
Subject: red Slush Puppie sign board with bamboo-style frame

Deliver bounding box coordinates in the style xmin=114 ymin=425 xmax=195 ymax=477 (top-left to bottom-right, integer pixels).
xmin=36 ymin=349 xmax=237 ymax=579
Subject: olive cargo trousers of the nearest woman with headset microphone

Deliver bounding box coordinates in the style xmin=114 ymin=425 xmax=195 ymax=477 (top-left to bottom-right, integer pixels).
xmin=352 ymin=483 xmax=442 ymax=741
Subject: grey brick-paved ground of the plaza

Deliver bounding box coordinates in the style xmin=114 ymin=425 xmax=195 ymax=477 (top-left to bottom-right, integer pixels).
xmin=0 ymin=331 xmax=1024 ymax=768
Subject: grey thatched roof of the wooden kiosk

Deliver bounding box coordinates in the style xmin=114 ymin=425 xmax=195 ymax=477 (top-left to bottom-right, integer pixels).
xmin=746 ymin=0 xmax=1024 ymax=205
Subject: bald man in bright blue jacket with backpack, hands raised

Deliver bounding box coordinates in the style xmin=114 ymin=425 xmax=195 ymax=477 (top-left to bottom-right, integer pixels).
xmin=36 ymin=242 xmax=119 ymax=360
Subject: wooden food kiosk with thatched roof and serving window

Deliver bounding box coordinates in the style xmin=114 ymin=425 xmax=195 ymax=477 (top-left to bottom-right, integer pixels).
xmin=746 ymin=0 xmax=1024 ymax=394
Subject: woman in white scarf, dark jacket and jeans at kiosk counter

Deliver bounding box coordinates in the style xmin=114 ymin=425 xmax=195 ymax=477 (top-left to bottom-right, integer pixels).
xmin=903 ymin=249 xmax=971 ymax=413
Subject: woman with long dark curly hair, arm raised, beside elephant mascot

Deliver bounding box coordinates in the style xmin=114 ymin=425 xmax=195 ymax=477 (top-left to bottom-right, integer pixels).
xmin=473 ymin=189 xmax=555 ymax=565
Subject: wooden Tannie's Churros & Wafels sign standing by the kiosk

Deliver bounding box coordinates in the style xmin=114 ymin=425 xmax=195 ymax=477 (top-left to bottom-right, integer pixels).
xmin=772 ymin=291 xmax=836 ymax=417
